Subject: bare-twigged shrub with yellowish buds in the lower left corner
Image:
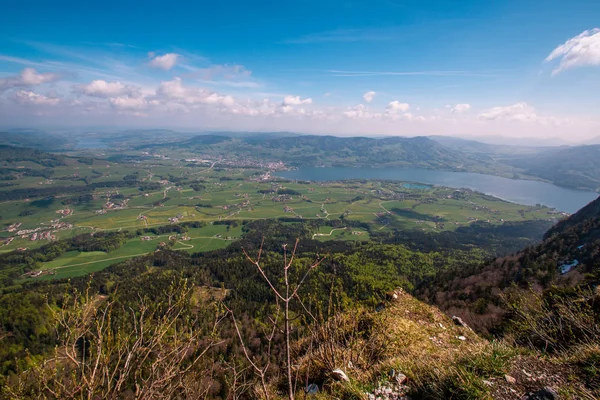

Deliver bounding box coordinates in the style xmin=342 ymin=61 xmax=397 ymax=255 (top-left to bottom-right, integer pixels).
xmin=2 ymin=282 xmax=220 ymax=399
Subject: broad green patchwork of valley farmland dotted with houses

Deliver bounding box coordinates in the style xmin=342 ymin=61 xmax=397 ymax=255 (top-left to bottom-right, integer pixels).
xmin=0 ymin=146 xmax=560 ymax=279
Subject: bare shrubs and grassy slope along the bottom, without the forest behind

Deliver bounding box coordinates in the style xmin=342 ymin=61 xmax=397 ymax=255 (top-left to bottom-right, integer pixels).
xmin=2 ymin=250 xmax=600 ymax=399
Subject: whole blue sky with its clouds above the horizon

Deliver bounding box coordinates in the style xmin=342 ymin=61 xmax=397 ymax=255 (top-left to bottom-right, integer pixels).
xmin=0 ymin=0 xmax=600 ymax=140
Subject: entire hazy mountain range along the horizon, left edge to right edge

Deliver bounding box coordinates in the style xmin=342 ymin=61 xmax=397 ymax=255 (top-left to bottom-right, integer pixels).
xmin=0 ymin=129 xmax=600 ymax=191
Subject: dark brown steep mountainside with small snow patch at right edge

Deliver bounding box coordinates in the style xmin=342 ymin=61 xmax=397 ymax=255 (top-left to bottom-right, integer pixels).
xmin=418 ymin=198 xmax=600 ymax=333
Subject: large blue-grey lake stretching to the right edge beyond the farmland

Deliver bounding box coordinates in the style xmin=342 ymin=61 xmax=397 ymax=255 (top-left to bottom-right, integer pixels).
xmin=277 ymin=167 xmax=598 ymax=213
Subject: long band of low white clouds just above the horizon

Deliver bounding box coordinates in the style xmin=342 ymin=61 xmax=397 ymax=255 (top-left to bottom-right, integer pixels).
xmin=0 ymin=49 xmax=600 ymax=138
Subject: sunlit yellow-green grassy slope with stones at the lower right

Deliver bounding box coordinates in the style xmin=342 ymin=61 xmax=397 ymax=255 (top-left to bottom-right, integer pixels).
xmin=299 ymin=290 xmax=597 ymax=399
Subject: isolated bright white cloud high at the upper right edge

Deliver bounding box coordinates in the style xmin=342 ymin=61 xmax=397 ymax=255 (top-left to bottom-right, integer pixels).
xmin=546 ymin=28 xmax=600 ymax=75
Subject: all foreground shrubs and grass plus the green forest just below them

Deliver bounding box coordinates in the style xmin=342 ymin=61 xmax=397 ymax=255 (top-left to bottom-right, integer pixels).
xmin=0 ymin=195 xmax=600 ymax=399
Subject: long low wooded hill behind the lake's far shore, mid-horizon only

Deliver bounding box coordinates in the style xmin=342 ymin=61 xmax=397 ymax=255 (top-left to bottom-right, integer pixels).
xmin=161 ymin=134 xmax=511 ymax=173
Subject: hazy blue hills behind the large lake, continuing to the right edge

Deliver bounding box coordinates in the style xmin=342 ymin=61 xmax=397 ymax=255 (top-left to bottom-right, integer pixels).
xmin=149 ymin=134 xmax=600 ymax=190
